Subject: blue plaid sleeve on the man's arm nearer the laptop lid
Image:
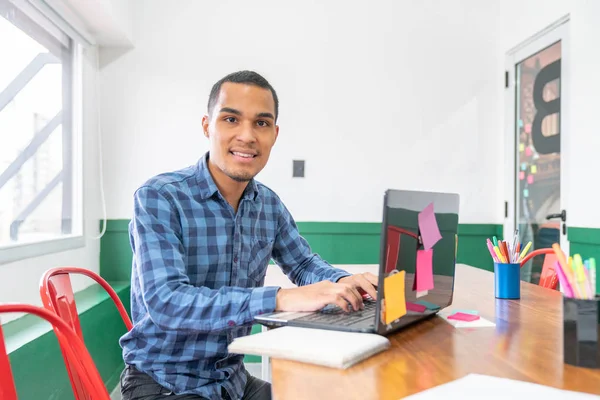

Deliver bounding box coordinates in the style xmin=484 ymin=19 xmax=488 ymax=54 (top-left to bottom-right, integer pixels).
xmin=272 ymin=202 xmax=351 ymax=286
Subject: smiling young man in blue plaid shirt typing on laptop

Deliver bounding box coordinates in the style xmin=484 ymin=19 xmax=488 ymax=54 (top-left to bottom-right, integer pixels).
xmin=121 ymin=71 xmax=377 ymax=400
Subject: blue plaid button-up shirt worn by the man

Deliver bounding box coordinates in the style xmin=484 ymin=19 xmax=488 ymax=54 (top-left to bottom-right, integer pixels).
xmin=120 ymin=153 xmax=349 ymax=399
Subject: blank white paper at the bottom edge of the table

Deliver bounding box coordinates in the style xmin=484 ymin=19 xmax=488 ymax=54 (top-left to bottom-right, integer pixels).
xmin=404 ymin=374 xmax=600 ymax=400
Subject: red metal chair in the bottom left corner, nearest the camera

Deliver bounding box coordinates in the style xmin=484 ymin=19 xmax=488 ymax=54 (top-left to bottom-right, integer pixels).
xmin=0 ymin=304 xmax=110 ymax=400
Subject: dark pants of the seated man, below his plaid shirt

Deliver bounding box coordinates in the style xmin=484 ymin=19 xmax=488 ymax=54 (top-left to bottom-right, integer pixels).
xmin=121 ymin=365 xmax=271 ymax=400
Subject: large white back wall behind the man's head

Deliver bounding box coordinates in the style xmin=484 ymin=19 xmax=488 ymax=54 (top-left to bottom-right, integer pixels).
xmin=101 ymin=0 xmax=503 ymax=223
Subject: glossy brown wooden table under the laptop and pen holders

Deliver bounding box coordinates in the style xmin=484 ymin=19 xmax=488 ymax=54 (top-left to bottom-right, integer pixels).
xmin=271 ymin=265 xmax=600 ymax=400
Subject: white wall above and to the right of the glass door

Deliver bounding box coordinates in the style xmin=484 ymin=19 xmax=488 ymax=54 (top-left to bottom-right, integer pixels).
xmin=498 ymin=0 xmax=600 ymax=228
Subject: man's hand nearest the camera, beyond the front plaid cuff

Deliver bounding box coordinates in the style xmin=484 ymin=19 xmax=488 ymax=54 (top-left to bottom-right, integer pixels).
xmin=275 ymin=277 xmax=364 ymax=311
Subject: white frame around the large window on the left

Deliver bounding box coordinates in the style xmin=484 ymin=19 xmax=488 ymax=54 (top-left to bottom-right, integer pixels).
xmin=0 ymin=0 xmax=85 ymax=266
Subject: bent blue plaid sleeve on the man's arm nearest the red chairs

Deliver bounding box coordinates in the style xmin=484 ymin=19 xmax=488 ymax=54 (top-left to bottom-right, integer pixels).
xmin=131 ymin=186 xmax=279 ymax=332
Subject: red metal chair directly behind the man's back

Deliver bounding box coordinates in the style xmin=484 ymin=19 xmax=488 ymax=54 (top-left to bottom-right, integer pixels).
xmin=40 ymin=267 xmax=133 ymax=400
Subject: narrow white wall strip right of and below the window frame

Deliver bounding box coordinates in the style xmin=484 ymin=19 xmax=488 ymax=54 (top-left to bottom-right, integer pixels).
xmin=0 ymin=48 xmax=101 ymax=322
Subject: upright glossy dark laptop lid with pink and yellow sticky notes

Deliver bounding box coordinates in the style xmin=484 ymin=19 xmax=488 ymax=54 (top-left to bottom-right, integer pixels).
xmin=378 ymin=190 xmax=459 ymax=332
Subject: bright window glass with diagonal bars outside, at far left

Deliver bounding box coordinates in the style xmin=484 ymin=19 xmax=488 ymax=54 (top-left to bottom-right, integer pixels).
xmin=0 ymin=0 xmax=83 ymax=263
